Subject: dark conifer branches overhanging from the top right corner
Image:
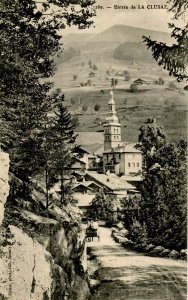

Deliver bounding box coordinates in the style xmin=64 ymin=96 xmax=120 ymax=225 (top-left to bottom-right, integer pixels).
xmin=143 ymin=0 xmax=188 ymax=81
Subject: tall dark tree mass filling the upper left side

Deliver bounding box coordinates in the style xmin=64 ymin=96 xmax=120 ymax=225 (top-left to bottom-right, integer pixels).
xmin=0 ymin=0 xmax=94 ymax=202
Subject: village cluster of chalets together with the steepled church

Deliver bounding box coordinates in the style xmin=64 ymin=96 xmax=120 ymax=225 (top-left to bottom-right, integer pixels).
xmin=62 ymin=91 xmax=143 ymax=211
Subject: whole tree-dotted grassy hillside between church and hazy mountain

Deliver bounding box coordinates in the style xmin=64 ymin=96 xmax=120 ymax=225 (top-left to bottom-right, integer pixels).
xmin=51 ymin=39 xmax=187 ymax=142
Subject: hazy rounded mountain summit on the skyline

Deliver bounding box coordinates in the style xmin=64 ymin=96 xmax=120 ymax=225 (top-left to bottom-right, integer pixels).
xmin=63 ymin=25 xmax=170 ymax=58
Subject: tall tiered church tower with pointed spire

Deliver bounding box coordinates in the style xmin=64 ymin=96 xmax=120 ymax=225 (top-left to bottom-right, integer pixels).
xmin=104 ymin=91 xmax=121 ymax=151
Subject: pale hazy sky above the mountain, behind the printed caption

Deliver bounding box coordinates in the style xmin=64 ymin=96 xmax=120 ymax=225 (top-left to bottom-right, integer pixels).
xmin=63 ymin=0 xmax=186 ymax=34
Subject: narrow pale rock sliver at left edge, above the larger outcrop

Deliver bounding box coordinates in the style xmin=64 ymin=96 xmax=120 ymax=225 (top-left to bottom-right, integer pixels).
xmin=0 ymin=151 xmax=9 ymax=226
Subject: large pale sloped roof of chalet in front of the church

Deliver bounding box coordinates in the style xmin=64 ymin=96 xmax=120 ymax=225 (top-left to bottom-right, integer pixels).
xmin=86 ymin=171 xmax=135 ymax=191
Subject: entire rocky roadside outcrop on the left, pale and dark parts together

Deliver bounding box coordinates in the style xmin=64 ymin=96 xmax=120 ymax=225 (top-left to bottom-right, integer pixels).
xmin=0 ymin=152 xmax=90 ymax=300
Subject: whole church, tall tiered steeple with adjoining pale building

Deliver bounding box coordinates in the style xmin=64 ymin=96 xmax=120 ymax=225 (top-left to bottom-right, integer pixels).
xmin=103 ymin=91 xmax=142 ymax=175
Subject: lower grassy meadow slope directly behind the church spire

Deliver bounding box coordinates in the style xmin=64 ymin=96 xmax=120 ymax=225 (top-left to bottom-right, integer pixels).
xmin=62 ymin=88 xmax=187 ymax=142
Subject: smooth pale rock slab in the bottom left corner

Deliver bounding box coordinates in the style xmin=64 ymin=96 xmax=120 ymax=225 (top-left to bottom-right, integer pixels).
xmin=0 ymin=226 xmax=53 ymax=300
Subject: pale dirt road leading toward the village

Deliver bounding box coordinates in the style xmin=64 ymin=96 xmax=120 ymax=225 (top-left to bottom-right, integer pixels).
xmin=88 ymin=227 xmax=187 ymax=300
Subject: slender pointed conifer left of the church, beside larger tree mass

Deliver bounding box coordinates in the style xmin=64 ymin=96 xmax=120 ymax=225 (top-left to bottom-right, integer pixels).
xmin=43 ymin=93 xmax=76 ymax=206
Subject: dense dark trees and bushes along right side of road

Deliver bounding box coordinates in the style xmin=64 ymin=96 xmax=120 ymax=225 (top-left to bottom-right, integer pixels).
xmin=139 ymin=118 xmax=187 ymax=250
